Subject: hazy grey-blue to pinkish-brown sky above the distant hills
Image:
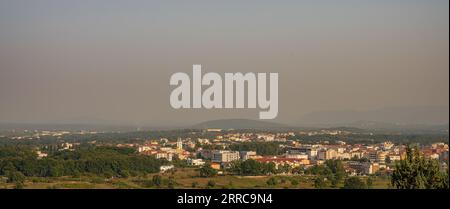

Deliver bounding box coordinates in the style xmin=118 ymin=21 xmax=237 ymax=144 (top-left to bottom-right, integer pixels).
xmin=0 ymin=0 xmax=449 ymax=125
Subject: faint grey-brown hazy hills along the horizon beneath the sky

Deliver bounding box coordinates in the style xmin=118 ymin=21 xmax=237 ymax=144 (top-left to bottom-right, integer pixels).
xmin=0 ymin=107 xmax=449 ymax=134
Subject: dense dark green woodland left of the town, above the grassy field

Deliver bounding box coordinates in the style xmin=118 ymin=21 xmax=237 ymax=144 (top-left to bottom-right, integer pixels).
xmin=0 ymin=146 xmax=166 ymax=180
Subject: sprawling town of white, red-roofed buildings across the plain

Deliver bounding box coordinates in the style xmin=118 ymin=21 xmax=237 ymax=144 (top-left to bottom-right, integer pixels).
xmin=137 ymin=132 xmax=448 ymax=175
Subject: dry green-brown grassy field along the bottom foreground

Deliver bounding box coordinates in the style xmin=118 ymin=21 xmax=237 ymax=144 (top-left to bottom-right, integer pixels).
xmin=0 ymin=168 xmax=389 ymax=189
